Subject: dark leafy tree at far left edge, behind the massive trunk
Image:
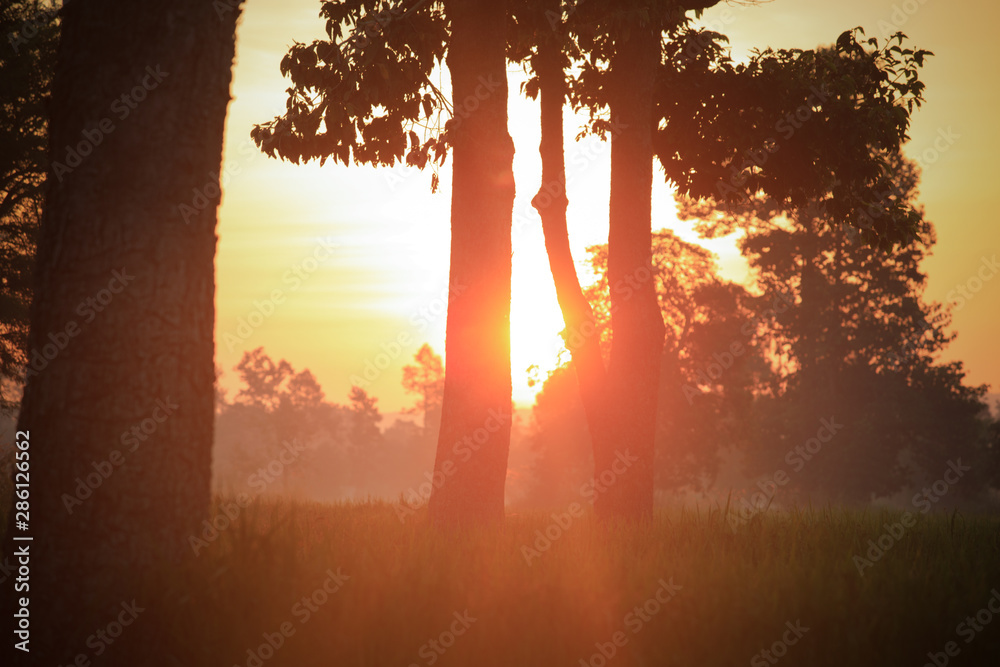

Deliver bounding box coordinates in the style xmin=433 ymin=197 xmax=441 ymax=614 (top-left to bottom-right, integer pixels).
xmin=0 ymin=0 xmax=62 ymax=414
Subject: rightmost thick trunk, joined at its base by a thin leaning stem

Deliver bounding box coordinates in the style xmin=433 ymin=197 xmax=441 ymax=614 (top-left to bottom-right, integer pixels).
xmin=594 ymin=14 xmax=664 ymax=519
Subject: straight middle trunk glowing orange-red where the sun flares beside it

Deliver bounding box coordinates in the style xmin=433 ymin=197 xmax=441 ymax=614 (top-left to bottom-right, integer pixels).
xmin=429 ymin=0 xmax=514 ymax=525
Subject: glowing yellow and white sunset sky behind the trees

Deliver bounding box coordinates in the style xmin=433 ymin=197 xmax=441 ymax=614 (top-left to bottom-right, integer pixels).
xmin=215 ymin=0 xmax=1000 ymax=413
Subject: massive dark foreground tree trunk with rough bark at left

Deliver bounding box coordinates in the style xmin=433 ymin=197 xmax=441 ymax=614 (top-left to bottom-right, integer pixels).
xmin=3 ymin=0 xmax=239 ymax=664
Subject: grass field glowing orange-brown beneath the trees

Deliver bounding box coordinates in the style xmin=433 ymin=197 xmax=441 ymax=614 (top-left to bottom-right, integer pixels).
xmin=137 ymin=501 xmax=1000 ymax=667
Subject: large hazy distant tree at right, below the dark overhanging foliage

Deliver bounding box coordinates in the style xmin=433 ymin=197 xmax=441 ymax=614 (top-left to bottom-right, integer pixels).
xmin=685 ymin=154 xmax=996 ymax=502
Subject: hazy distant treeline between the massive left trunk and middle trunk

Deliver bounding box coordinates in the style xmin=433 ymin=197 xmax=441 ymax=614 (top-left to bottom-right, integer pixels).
xmin=213 ymin=346 xmax=443 ymax=500
